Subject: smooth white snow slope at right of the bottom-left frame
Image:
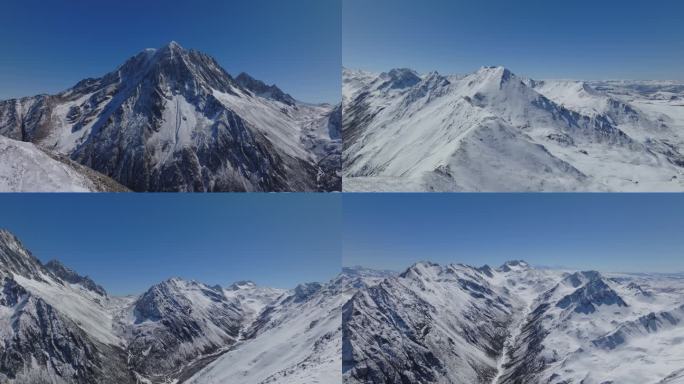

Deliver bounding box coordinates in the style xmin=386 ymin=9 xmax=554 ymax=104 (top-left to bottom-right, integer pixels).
xmin=187 ymin=281 xmax=349 ymax=384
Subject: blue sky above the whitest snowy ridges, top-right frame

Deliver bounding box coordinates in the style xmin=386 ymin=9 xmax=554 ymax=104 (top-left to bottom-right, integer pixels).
xmin=342 ymin=0 xmax=684 ymax=80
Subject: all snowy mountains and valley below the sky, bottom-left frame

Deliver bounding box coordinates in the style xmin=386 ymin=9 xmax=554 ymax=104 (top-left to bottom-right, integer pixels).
xmin=0 ymin=230 xmax=342 ymax=384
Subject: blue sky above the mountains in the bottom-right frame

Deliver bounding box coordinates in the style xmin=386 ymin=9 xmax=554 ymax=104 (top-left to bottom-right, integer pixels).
xmin=343 ymin=193 xmax=684 ymax=272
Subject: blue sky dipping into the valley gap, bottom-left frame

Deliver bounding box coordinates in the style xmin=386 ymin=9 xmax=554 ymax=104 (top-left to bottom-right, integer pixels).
xmin=0 ymin=193 xmax=342 ymax=294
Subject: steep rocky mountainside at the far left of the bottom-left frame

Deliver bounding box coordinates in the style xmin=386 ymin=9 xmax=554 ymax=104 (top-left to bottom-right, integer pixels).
xmin=0 ymin=230 xmax=135 ymax=384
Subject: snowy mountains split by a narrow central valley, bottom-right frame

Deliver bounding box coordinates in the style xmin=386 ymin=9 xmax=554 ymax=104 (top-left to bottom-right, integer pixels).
xmin=343 ymin=261 xmax=684 ymax=384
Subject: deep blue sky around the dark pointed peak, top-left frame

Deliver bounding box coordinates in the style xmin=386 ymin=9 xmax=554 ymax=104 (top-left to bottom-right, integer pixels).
xmin=0 ymin=0 xmax=341 ymax=102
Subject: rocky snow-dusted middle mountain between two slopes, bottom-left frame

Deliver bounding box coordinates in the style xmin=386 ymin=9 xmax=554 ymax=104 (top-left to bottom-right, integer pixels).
xmin=123 ymin=279 xmax=243 ymax=382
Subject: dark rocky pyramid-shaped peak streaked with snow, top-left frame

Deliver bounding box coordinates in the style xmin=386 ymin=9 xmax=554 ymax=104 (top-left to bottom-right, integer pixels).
xmin=0 ymin=42 xmax=341 ymax=191
